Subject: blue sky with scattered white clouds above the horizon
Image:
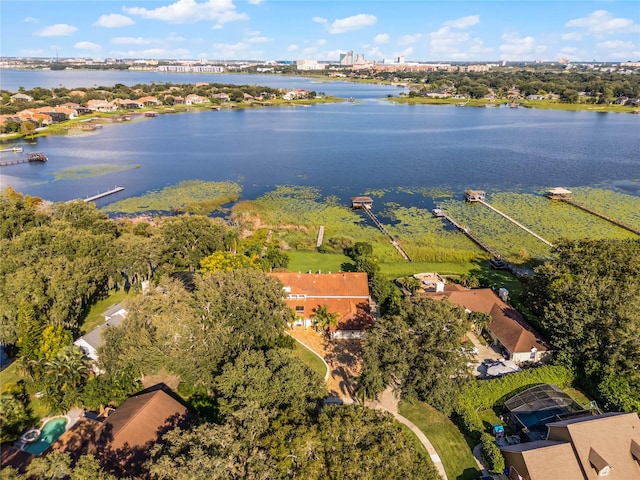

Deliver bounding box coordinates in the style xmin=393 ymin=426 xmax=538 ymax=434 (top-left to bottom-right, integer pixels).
xmin=0 ymin=0 xmax=640 ymax=61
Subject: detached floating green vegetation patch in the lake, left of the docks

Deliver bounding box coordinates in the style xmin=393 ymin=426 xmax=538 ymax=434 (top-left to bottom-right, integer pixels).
xmin=102 ymin=180 xmax=242 ymax=215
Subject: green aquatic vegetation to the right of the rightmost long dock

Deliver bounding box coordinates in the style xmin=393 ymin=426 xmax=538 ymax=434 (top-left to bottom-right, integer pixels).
xmin=571 ymin=187 xmax=640 ymax=229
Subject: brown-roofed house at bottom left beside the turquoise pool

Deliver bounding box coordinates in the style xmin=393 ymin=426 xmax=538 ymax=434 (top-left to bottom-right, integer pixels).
xmin=51 ymin=390 xmax=191 ymax=479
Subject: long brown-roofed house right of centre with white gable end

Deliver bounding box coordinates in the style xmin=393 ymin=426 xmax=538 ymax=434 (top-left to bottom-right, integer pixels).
xmin=426 ymin=284 xmax=552 ymax=363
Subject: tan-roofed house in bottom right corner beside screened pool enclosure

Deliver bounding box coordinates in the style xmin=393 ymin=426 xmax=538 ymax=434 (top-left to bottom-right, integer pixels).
xmin=500 ymin=412 xmax=640 ymax=480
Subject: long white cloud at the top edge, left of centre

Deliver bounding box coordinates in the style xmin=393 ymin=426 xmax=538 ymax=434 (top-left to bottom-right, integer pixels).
xmin=123 ymin=0 xmax=249 ymax=26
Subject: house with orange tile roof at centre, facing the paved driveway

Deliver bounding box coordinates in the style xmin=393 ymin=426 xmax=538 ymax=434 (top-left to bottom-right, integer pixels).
xmin=270 ymin=272 xmax=373 ymax=338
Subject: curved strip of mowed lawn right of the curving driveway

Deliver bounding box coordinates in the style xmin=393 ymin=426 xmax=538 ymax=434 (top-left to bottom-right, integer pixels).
xmin=399 ymin=402 xmax=480 ymax=480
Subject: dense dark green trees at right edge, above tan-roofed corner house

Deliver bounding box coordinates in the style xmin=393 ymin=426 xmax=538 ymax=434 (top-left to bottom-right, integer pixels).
xmin=528 ymin=240 xmax=640 ymax=411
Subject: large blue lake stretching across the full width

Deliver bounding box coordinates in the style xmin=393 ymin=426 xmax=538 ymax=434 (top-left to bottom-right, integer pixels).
xmin=0 ymin=70 xmax=640 ymax=205
